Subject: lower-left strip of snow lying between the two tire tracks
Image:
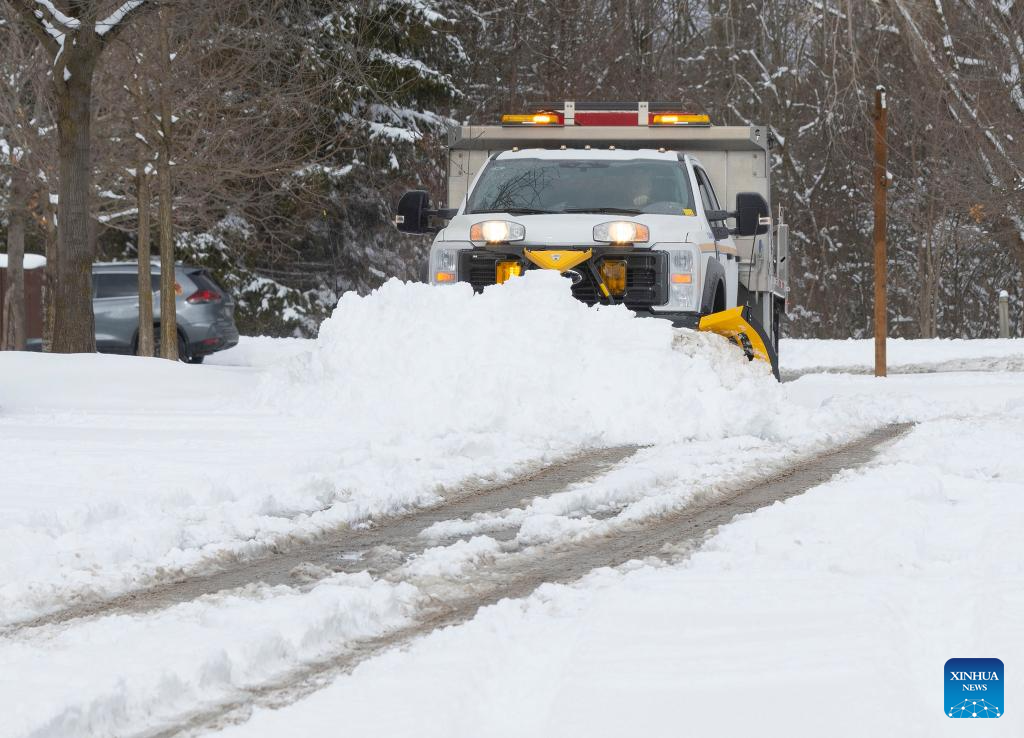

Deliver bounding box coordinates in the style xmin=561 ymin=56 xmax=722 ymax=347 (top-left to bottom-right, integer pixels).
xmin=0 ymin=574 xmax=420 ymax=736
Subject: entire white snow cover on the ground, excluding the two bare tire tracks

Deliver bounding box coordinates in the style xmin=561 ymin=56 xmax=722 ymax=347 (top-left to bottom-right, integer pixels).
xmin=0 ymin=273 xmax=1024 ymax=736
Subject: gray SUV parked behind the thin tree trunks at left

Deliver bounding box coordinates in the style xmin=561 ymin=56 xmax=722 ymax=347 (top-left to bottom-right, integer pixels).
xmin=92 ymin=262 xmax=239 ymax=363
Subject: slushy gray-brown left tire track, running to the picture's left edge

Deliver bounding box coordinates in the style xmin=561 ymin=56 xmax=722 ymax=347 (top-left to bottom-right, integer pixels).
xmin=12 ymin=446 xmax=639 ymax=636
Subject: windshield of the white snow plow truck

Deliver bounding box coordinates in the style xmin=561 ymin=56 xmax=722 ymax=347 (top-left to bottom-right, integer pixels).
xmin=466 ymin=159 xmax=693 ymax=215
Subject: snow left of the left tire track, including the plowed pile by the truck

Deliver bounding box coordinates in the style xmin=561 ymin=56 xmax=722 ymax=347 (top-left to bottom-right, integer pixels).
xmin=0 ymin=273 xmax=802 ymax=621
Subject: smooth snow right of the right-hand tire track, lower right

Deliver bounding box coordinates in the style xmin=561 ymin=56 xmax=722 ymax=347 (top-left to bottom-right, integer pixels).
xmin=214 ymin=376 xmax=1024 ymax=738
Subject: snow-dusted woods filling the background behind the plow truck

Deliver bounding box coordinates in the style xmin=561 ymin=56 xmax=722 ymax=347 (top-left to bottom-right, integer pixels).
xmin=0 ymin=0 xmax=1024 ymax=337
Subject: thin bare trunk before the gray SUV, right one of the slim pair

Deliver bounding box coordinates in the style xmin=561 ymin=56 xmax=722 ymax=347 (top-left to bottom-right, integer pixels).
xmin=157 ymin=8 xmax=179 ymax=361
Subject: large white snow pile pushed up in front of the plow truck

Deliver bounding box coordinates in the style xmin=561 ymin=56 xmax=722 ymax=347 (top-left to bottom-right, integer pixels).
xmin=265 ymin=270 xmax=784 ymax=445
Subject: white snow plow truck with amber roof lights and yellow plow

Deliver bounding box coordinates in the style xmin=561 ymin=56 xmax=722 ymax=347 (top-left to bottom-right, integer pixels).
xmin=395 ymin=101 xmax=787 ymax=378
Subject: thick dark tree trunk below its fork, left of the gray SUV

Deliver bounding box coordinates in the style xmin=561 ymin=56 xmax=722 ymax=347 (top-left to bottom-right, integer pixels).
xmin=50 ymin=46 xmax=96 ymax=353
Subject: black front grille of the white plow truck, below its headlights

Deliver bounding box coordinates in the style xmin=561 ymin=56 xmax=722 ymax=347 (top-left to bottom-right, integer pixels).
xmin=459 ymin=249 xmax=669 ymax=309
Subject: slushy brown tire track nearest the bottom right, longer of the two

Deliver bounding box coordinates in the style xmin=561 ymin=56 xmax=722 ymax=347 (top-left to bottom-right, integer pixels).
xmin=138 ymin=423 xmax=912 ymax=738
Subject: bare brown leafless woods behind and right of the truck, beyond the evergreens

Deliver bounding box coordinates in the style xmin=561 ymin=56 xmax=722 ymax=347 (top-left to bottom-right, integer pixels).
xmin=465 ymin=0 xmax=1024 ymax=337
